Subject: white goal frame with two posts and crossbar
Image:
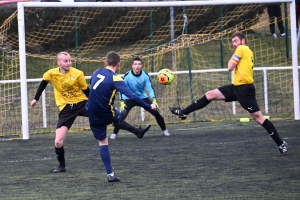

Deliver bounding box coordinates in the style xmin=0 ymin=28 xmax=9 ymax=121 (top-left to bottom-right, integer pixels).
xmin=18 ymin=0 xmax=300 ymax=139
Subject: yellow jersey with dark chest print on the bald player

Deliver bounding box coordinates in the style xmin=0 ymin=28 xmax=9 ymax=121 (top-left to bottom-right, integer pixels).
xmin=43 ymin=67 xmax=88 ymax=110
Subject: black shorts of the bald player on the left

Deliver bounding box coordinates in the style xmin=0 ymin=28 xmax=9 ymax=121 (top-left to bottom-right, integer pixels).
xmin=56 ymin=101 xmax=88 ymax=129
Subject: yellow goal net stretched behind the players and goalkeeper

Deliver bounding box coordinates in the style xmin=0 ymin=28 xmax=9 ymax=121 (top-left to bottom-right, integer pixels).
xmin=0 ymin=0 xmax=298 ymax=138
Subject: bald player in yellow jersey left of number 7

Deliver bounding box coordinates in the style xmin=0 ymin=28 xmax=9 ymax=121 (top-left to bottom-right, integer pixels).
xmin=31 ymin=52 xmax=149 ymax=173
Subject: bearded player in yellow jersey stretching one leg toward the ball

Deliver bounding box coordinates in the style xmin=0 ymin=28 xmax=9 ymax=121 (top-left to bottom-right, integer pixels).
xmin=169 ymin=32 xmax=287 ymax=156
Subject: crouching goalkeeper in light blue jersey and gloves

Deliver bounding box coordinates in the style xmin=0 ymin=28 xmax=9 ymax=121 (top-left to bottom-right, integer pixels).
xmin=110 ymin=58 xmax=170 ymax=139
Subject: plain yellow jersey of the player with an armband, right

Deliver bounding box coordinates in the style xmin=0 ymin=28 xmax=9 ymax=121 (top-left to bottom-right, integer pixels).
xmin=231 ymin=45 xmax=254 ymax=86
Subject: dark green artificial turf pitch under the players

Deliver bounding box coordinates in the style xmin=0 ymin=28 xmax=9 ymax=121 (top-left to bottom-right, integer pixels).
xmin=0 ymin=121 xmax=300 ymax=200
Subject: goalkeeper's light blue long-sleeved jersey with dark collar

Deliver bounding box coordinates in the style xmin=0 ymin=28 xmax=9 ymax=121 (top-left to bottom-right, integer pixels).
xmin=121 ymin=70 xmax=155 ymax=100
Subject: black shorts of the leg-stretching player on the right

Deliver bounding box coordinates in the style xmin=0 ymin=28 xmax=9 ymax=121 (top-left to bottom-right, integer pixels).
xmin=218 ymin=84 xmax=260 ymax=113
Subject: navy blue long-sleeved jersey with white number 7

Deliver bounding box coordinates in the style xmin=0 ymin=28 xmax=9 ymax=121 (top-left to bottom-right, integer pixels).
xmin=86 ymin=68 xmax=151 ymax=120
